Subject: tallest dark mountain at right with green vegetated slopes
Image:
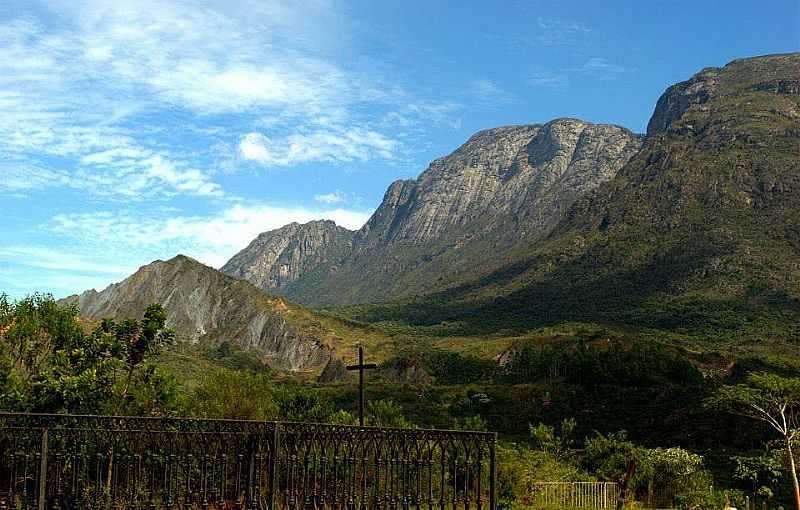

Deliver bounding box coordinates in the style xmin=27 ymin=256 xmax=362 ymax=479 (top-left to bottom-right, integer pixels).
xmin=354 ymin=53 xmax=800 ymax=342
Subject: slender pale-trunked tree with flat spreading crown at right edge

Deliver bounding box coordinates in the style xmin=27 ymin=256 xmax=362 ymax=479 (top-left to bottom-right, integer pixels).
xmin=706 ymin=373 xmax=800 ymax=510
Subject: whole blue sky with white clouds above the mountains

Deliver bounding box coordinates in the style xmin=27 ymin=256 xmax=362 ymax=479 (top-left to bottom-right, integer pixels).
xmin=0 ymin=0 xmax=800 ymax=297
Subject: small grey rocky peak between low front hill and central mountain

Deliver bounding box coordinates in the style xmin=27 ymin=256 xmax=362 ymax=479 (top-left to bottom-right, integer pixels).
xmin=221 ymin=221 xmax=353 ymax=292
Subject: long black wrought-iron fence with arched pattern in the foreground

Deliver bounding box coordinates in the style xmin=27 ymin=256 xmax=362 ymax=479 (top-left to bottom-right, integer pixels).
xmin=0 ymin=413 xmax=496 ymax=510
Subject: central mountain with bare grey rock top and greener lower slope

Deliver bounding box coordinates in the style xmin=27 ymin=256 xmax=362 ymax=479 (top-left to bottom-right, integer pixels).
xmin=286 ymin=119 xmax=641 ymax=304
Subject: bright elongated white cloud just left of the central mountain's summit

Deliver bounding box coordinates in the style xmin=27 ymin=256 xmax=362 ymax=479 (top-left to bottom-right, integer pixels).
xmin=239 ymin=128 xmax=397 ymax=166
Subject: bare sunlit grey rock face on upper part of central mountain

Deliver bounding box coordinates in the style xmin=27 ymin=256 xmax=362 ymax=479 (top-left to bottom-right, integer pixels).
xmin=356 ymin=119 xmax=639 ymax=250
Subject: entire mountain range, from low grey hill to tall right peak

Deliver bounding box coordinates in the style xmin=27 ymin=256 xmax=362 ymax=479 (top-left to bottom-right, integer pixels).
xmin=64 ymin=54 xmax=800 ymax=370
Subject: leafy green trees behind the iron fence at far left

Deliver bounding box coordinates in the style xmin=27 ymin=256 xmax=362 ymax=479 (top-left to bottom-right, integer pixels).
xmin=0 ymin=294 xmax=175 ymax=414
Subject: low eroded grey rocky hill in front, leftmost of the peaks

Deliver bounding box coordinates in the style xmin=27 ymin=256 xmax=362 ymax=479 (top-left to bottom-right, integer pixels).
xmin=66 ymin=255 xmax=330 ymax=370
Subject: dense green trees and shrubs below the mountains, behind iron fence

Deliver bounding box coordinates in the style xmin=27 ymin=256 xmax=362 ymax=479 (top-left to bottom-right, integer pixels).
xmin=0 ymin=296 xmax=800 ymax=508
